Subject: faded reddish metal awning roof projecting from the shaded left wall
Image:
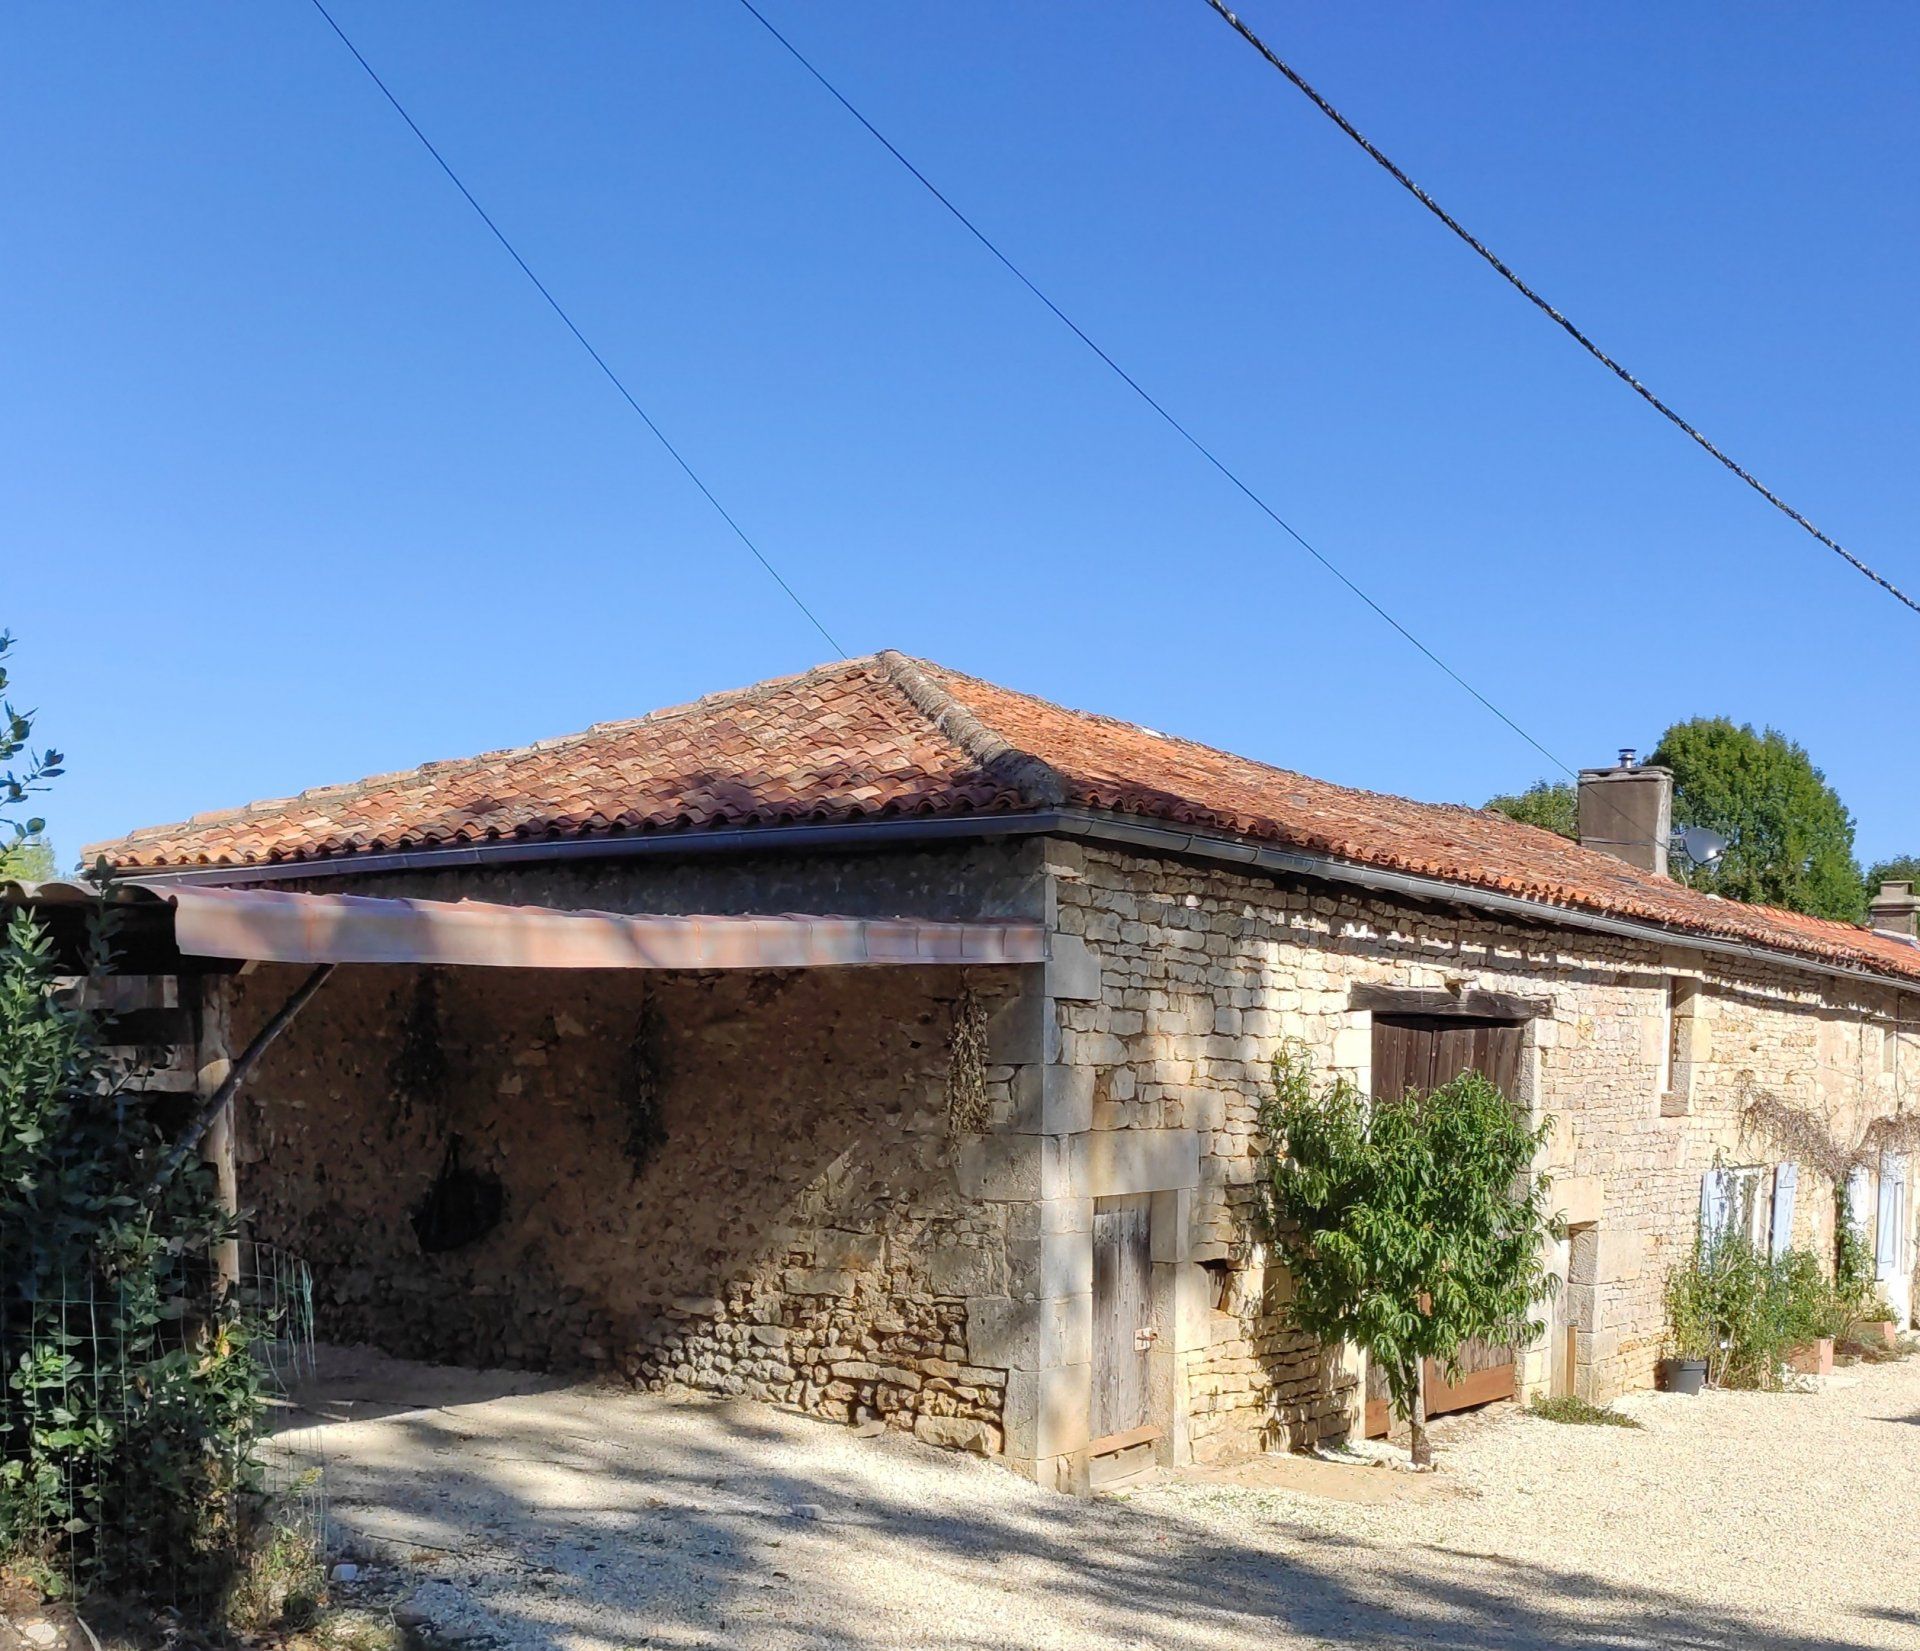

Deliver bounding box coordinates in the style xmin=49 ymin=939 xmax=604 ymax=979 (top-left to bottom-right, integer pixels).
xmin=0 ymin=881 xmax=1046 ymax=973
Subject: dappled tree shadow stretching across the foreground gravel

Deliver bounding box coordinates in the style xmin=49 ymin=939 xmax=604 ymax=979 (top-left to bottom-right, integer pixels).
xmin=299 ymin=1392 xmax=1916 ymax=1651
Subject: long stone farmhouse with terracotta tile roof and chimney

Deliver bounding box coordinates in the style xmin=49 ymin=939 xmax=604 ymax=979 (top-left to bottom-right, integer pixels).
xmin=88 ymin=653 xmax=1920 ymax=1490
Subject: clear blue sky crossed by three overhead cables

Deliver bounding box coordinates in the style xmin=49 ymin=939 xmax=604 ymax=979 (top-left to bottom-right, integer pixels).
xmin=0 ymin=0 xmax=1920 ymax=858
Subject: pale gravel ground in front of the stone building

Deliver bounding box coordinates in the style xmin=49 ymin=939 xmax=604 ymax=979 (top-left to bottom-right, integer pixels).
xmin=284 ymin=1350 xmax=1920 ymax=1651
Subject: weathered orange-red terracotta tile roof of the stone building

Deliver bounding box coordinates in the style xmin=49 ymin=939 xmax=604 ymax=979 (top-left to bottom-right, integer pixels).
xmin=86 ymin=653 xmax=1920 ymax=979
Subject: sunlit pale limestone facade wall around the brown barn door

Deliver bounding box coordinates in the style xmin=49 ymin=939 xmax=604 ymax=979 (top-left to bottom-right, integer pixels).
xmin=1052 ymin=845 xmax=1920 ymax=1459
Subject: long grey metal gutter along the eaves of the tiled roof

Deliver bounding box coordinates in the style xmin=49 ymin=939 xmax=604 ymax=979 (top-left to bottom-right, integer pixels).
xmin=120 ymin=808 xmax=1920 ymax=993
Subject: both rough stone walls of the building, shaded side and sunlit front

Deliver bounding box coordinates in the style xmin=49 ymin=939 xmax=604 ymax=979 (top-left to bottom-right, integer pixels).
xmin=217 ymin=825 xmax=1920 ymax=1488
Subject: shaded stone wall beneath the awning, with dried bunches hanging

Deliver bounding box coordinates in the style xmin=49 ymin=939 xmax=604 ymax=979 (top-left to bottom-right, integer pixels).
xmin=230 ymin=948 xmax=1012 ymax=1451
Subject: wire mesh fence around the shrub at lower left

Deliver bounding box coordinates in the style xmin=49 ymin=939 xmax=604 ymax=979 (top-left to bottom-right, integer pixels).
xmin=0 ymin=1242 xmax=326 ymax=1613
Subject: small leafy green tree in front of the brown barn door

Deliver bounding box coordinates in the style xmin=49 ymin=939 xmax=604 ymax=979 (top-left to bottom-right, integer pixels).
xmin=1260 ymin=1044 xmax=1559 ymax=1467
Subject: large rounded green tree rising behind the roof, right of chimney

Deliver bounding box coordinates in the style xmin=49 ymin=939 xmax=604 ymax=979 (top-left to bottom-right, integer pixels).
xmin=1649 ymin=716 xmax=1866 ymax=923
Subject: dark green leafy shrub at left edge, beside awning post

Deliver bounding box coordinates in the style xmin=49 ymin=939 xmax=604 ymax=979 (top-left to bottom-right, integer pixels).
xmin=0 ymin=912 xmax=263 ymax=1603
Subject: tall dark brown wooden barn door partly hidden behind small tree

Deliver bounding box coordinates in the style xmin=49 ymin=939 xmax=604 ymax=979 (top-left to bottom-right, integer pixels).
xmin=1367 ymin=1014 xmax=1521 ymax=1436
